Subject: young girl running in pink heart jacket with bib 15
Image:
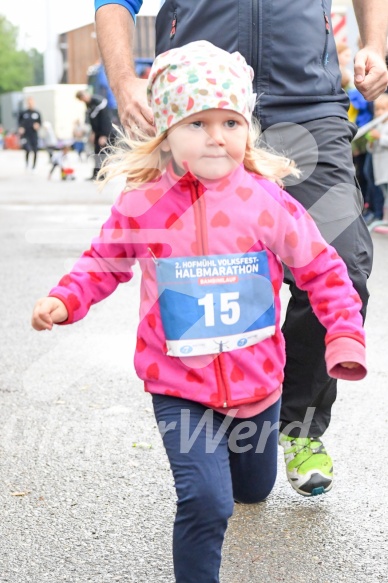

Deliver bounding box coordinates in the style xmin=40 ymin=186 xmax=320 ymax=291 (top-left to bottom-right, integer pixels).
xmin=32 ymin=41 xmax=366 ymax=583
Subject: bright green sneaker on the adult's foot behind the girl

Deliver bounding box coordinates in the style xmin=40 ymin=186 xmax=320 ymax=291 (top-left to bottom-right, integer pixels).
xmin=279 ymin=433 xmax=333 ymax=496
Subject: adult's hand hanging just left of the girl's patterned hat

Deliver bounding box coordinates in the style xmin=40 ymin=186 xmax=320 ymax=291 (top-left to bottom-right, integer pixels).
xmin=116 ymin=77 xmax=155 ymax=135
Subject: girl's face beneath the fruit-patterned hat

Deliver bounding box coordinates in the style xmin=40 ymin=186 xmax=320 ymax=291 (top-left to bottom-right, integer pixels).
xmin=162 ymin=109 xmax=249 ymax=180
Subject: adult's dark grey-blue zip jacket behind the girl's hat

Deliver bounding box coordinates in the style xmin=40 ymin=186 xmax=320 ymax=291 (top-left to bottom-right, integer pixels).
xmin=156 ymin=0 xmax=348 ymax=128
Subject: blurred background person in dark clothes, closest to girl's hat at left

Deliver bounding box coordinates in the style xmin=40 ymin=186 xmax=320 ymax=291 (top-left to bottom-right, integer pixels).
xmin=75 ymin=90 xmax=113 ymax=180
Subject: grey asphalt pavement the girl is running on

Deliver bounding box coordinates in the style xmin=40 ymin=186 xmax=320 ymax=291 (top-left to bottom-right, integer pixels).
xmin=0 ymin=151 xmax=388 ymax=583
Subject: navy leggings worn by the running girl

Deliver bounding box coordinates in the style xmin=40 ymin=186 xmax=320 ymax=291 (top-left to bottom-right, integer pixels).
xmin=153 ymin=395 xmax=280 ymax=583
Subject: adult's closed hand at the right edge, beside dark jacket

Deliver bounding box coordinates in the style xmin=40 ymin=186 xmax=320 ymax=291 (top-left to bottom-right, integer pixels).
xmin=354 ymin=46 xmax=388 ymax=101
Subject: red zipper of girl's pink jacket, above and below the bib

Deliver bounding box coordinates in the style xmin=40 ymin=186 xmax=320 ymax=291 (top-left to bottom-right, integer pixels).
xmin=191 ymin=180 xmax=229 ymax=408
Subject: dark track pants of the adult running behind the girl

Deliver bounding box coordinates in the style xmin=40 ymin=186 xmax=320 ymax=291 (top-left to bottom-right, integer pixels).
xmin=264 ymin=117 xmax=373 ymax=437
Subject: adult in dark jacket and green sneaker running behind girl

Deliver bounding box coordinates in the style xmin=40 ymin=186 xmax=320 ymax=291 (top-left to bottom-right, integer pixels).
xmin=95 ymin=0 xmax=388 ymax=496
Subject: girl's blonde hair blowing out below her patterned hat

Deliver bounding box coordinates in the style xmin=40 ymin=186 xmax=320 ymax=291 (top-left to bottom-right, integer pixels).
xmin=98 ymin=120 xmax=300 ymax=191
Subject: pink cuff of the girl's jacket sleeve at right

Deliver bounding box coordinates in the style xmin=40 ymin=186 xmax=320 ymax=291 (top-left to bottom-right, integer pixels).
xmin=325 ymin=337 xmax=367 ymax=381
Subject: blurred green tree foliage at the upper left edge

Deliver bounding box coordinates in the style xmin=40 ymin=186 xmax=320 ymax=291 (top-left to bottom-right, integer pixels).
xmin=0 ymin=15 xmax=43 ymax=94
